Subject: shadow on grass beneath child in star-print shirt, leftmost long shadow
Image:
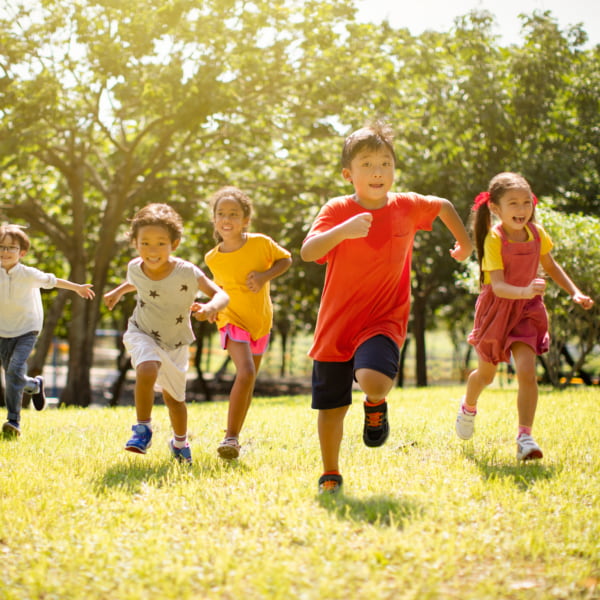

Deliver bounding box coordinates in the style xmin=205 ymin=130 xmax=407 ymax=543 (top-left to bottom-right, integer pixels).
xmin=95 ymin=455 xmax=248 ymax=494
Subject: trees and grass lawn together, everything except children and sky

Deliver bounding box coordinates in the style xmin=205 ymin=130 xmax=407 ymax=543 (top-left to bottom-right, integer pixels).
xmin=0 ymin=0 xmax=600 ymax=600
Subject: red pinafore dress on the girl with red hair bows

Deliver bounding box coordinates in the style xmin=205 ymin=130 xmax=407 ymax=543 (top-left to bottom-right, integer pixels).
xmin=467 ymin=223 xmax=550 ymax=365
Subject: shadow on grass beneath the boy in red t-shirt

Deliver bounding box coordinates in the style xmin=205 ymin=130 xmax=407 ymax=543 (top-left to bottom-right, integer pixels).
xmin=318 ymin=492 xmax=423 ymax=529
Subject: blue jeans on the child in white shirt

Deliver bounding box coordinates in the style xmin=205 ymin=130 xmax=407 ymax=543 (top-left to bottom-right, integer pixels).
xmin=0 ymin=331 xmax=38 ymax=423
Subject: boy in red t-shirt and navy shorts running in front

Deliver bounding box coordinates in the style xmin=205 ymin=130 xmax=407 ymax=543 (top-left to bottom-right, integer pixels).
xmin=301 ymin=122 xmax=472 ymax=493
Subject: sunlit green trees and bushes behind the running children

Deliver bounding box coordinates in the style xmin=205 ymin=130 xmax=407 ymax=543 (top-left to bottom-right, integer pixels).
xmin=0 ymin=0 xmax=600 ymax=406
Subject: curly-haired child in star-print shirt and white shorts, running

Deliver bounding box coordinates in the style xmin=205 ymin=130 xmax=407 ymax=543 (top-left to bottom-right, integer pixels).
xmin=104 ymin=204 xmax=229 ymax=463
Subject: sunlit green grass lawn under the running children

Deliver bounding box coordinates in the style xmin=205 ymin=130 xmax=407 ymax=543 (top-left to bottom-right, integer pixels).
xmin=0 ymin=387 xmax=600 ymax=600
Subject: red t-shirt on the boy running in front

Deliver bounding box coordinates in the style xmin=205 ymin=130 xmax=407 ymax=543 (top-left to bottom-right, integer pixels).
xmin=306 ymin=193 xmax=441 ymax=362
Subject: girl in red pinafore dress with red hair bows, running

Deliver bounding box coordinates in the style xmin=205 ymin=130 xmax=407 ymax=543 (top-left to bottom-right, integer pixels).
xmin=456 ymin=173 xmax=594 ymax=460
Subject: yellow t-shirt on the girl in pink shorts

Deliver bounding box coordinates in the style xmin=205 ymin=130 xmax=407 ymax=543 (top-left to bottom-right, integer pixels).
xmin=204 ymin=233 xmax=291 ymax=340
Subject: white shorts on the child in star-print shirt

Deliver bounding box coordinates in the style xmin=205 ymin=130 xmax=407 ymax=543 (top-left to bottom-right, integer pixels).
xmin=123 ymin=331 xmax=190 ymax=402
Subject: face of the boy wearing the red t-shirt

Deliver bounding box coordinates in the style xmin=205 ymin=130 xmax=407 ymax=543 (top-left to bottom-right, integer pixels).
xmin=342 ymin=147 xmax=395 ymax=209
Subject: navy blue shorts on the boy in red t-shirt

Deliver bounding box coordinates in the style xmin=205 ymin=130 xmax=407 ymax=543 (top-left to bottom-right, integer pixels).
xmin=311 ymin=335 xmax=400 ymax=410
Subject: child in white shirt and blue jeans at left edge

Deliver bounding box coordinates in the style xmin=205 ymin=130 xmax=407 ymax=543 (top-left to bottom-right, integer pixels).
xmin=0 ymin=225 xmax=94 ymax=437
